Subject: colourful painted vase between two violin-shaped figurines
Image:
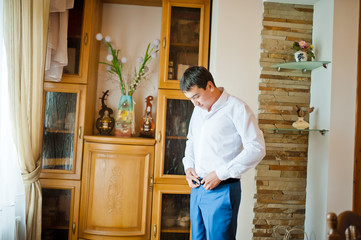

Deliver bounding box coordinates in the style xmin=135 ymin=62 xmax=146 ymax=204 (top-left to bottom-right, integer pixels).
xmin=115 ymin=95 xmax=134 ymax=137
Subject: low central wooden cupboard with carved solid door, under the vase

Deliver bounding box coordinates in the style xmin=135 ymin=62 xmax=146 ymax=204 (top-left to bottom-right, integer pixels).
xmin=79 ymin=136 xmax=154 ymax=240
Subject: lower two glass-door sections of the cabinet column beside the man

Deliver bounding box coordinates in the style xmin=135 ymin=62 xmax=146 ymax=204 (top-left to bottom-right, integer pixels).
xmin=151 ymin=89 xmax=193 ymax=240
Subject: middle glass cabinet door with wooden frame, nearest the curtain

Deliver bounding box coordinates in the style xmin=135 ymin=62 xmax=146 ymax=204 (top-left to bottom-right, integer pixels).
xmin=41 ymin=83 xmax=85 ymax=179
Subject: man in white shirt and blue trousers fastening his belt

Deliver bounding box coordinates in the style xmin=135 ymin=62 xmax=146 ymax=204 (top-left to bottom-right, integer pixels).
xmin=180 ymin=66 xmax=265 ymax=240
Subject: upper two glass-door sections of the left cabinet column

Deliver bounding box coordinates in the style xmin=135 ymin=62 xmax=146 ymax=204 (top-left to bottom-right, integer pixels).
xmin=40 ymin=0 xmax=102 ymax=180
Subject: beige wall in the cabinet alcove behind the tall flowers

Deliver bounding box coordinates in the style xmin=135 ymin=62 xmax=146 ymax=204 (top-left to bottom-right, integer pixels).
xmin=95 ymin=4 xmax=162 ymax=135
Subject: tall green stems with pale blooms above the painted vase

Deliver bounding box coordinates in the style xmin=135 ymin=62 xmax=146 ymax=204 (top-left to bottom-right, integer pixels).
xmin=96 ymin=33 xmax=159 ymax=96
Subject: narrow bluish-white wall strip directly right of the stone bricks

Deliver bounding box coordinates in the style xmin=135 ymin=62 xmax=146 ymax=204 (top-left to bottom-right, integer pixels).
xmin=305 ymin=0 xmax=334 ymax=239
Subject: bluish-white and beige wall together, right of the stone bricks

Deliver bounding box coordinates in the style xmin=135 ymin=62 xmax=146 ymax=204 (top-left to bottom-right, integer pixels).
xmin=306 ymin=0 xmax=359 ymax=239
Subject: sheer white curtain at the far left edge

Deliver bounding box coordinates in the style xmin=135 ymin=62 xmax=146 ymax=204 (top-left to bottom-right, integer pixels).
xmin=0 ymin=0 xmax=26 ymax=240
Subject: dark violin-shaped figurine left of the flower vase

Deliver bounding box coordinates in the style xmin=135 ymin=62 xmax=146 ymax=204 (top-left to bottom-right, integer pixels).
xmin=95 ymin=90 xmax=115 ymax=135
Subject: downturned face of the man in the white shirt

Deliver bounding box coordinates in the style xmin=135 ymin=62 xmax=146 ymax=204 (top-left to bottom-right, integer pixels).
xmin=184 ymin=81 xmax=215 ymax=111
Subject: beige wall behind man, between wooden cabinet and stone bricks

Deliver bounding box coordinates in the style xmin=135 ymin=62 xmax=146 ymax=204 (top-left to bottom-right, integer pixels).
xmin=210 ymin=0 xmax=263 ymax=240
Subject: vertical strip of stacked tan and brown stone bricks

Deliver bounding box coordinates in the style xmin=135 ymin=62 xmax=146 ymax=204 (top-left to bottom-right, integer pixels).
xmin=253 ymin=2 xmax=313 ymax=240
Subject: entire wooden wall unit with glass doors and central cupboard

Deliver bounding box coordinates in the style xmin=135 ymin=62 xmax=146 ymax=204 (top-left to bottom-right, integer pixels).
xmin=40 ymin=0 xmax=210 ymax=240
